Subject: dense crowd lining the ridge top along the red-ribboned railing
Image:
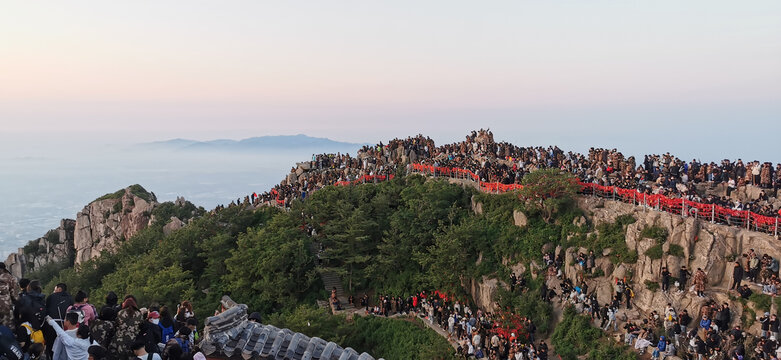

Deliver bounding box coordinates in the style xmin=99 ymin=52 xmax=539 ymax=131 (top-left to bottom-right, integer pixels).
xmin=218 ymin=129 xmax=781 ymax=228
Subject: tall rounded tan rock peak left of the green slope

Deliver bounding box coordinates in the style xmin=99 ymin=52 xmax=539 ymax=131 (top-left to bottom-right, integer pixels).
xmin=73 ymin=185 xmax=158 ymax=264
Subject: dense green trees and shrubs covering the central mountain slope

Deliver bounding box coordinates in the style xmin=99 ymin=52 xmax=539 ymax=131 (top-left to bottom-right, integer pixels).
xmin=33 ymin=174 xmax=604 ymax=359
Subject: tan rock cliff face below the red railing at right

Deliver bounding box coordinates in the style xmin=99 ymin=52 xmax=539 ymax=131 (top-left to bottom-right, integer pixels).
xmin=564 ymin=197 xmax=781 ymax=334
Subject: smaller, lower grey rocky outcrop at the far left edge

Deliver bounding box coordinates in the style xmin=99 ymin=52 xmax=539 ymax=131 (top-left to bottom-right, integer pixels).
xmin=5 ymin=219 xmax=76 ymax=278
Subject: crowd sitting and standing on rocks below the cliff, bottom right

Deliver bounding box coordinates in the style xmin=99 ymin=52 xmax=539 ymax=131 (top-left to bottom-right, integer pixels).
xmin=544 ymin=243 xmax=781 ymax=360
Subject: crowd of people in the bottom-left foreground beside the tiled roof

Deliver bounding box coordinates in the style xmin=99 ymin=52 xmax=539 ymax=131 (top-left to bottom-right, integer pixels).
xmin=0 ymin=263 xmax=206 ymax=360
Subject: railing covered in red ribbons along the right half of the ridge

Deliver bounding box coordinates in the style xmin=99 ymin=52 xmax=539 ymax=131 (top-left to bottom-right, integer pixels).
xmin=412 ymin=164 xmax=781 ymax=236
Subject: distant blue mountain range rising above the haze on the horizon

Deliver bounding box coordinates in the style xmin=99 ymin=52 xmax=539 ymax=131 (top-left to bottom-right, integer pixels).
xmin=140 ymin=134 xmax=366 ymax=152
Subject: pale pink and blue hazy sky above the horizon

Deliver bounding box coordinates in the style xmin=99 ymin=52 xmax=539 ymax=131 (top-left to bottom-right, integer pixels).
xmin=0 ymin=0 xmax=781 ymax=161
